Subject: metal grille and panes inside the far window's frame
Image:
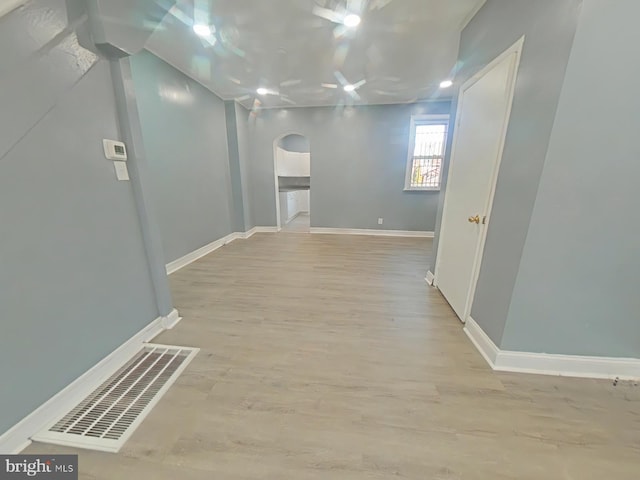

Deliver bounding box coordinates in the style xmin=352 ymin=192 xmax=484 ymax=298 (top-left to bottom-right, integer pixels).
xmin=410 ymin=124 xmax=447 ymax=189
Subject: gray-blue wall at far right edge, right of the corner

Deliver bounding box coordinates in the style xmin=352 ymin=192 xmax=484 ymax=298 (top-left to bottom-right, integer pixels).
xmin=502 ymin=0 xmax=640 ymax=358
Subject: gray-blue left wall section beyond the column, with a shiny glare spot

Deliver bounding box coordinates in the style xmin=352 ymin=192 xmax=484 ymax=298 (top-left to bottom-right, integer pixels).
xmin=131 ymin=51 xmax=235 ymax=263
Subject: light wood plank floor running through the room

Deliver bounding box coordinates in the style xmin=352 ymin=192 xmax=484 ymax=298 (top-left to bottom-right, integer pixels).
xmin=26 ymin=233 xmax=640 ymax=480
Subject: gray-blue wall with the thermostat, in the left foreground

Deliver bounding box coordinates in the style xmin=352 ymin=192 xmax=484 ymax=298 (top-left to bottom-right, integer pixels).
xmin=0 ymin=0 xmax=158 ymax=433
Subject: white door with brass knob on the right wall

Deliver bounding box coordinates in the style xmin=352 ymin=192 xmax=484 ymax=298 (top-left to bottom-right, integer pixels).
xmin=434 ymin=40 xmax=522 ymax=322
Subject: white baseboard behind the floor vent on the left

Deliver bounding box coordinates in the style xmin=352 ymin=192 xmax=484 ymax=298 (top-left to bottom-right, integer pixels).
xmin=0 ymin=309 xmax=180 ymax=454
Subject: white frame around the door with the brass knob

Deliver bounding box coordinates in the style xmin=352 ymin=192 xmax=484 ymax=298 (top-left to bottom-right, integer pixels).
xmin=433 ymin=35 xmax=524 ymax=323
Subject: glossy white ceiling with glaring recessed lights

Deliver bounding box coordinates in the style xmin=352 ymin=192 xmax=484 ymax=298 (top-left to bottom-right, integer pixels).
xmin=147 ymin=0 xmax=485 ymax=108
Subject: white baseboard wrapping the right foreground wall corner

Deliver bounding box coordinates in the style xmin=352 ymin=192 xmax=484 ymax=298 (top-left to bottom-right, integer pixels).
xmin=464 ymin=317 xmax=640 ymax=380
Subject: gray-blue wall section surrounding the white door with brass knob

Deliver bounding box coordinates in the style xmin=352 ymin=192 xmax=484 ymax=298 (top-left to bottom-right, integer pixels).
xmin=431 ymin=0 xmax=581 ymax=345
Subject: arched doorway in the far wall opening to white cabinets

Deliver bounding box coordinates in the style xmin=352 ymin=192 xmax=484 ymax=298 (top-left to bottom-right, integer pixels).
xmin=273 ymin=133 xmax=311 ymax=233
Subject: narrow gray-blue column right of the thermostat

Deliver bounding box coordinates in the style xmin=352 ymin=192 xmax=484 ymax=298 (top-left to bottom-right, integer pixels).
xmin=111 ymin=57 xmax=173 ymax=316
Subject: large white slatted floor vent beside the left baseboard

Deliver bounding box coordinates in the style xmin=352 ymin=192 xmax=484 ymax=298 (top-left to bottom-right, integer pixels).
xmin=33 ymin=344 xmax=199 ymax=452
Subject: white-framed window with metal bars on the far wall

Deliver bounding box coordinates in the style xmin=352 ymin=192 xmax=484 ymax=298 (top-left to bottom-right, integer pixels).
xmin=404 ymin=115 xmax=449 ymax=190
